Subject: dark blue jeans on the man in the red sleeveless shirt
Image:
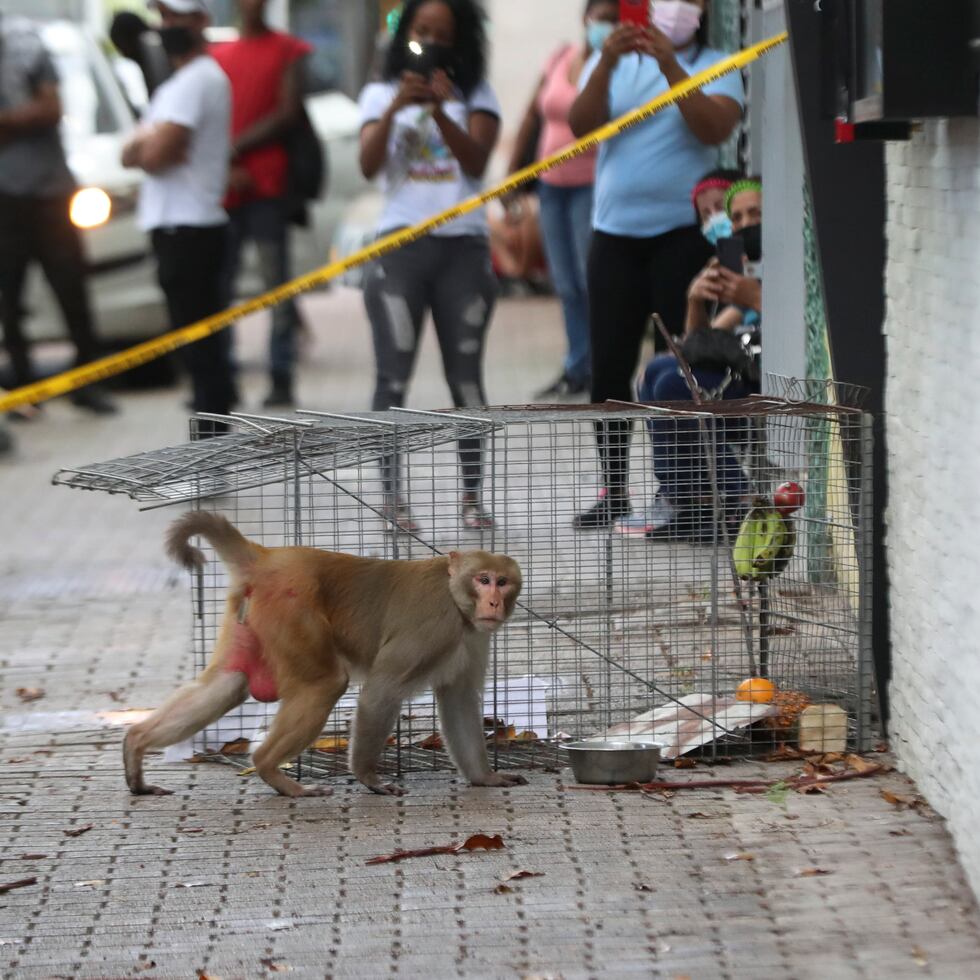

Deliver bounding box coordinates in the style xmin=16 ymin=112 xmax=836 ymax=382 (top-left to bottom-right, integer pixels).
xmin=222 ymin=198 xmax=299 ymax=384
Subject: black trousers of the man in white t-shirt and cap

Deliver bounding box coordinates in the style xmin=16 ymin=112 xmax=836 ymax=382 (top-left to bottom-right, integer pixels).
xmin=152 ymin=225 xmax=235 ymax=424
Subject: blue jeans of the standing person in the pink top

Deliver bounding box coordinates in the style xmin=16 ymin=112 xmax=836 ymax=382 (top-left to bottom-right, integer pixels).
xmin=538 ymin=182 xmax=592 ymax=382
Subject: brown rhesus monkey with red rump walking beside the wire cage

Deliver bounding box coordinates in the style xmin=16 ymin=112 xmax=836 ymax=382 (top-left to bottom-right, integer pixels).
xmin=123 ymin=511 xmax=527 ymax=796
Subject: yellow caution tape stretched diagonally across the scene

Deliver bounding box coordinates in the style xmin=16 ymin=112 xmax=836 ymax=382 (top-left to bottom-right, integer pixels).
xmin=0 ymin=31 xmax=788 ymax=412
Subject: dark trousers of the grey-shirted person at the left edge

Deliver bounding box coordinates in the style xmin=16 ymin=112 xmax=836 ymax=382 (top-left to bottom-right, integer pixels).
xmin=0 ymin=194 xmax=99 ymax=385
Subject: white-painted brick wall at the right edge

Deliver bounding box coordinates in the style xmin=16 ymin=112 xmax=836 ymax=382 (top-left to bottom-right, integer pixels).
xmin=885 ymin=119 xmax=980 ymax=892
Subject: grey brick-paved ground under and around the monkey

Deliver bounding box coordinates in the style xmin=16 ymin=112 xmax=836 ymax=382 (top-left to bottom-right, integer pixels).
xmin=0 ymin=291 xmax=980 ymax=980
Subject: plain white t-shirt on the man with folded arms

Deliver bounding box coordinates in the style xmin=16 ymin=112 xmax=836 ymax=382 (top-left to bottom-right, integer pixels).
xmin=138 ymin=54 xmax=231 ymax=231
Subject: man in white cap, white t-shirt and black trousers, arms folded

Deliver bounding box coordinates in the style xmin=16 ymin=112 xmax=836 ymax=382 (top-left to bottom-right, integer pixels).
xmin=122 ymin=0 xmax=236 ymax=434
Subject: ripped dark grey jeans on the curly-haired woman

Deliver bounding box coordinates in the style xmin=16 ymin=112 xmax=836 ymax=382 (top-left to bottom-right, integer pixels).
xmin=364 ymin=235 xmax=497 ymax=494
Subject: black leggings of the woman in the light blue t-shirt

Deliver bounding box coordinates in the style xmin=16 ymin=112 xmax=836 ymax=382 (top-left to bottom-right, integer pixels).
xmin=589 ymin=225 xmax=712 ymax=496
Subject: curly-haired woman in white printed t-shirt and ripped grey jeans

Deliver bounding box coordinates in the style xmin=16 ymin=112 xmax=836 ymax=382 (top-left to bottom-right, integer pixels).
xmin=360 ymin=0 xmax=500 ymax=531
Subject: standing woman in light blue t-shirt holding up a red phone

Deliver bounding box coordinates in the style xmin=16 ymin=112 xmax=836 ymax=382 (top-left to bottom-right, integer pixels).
xmin=569 ymin=0 xmax=744 ymax=530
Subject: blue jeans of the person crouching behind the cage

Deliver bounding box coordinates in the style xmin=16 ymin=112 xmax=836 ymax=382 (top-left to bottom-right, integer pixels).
xmin=637 ymin=354 xmax=751 ymax=508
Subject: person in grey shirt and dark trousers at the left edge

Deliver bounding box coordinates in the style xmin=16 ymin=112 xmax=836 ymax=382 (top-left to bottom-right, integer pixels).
xmin=0 ymin=12 xmax=116 ymax=418
